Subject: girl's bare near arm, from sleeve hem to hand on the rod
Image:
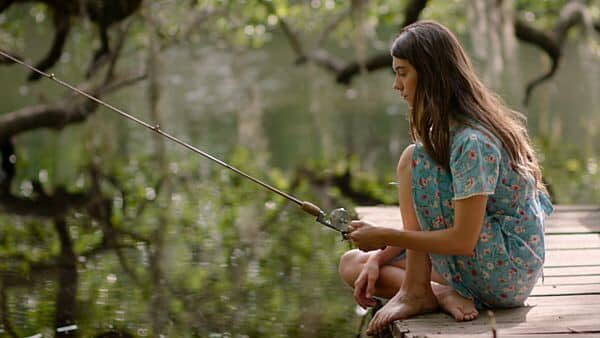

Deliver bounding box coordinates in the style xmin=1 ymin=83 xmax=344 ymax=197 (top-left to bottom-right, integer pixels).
xmin=348 ymin=195 xmax=487 ymax=256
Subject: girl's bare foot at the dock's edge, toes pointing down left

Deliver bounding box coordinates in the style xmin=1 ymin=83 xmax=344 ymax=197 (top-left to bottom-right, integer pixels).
xmin=367 ymin=289 xmax=438 ymax=335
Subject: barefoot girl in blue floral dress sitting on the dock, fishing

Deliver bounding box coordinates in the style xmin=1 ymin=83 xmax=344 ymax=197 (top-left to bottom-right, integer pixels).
xmin=339 ymin=21 xmax=552 ymax=334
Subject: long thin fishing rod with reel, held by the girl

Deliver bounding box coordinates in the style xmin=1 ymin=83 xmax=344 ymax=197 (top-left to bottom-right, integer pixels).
xmin=0 ymin=50 xmax=352 ymax=235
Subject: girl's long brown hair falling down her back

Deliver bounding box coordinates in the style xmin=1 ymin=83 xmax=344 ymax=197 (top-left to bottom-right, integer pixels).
xmin=391 ymin=21 xmax=546 ymax=191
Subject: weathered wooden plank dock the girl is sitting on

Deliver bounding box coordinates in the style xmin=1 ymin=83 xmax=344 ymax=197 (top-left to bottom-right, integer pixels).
xmin=357 ymin=205 xmax=600 ymax=338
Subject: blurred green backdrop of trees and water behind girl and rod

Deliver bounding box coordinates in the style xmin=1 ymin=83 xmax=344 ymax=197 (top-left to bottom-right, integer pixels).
xmin=0 ymin=0 xmax=600 ymax=337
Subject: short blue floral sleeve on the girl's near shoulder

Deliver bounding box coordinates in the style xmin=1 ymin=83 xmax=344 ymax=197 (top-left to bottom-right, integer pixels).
xmin=450 ymin=133 xmax=501 ymax=199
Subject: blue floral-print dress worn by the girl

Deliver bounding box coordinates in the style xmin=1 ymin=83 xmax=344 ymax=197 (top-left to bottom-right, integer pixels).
xmin=412 ymin=126 xmax=553 ymax=308
